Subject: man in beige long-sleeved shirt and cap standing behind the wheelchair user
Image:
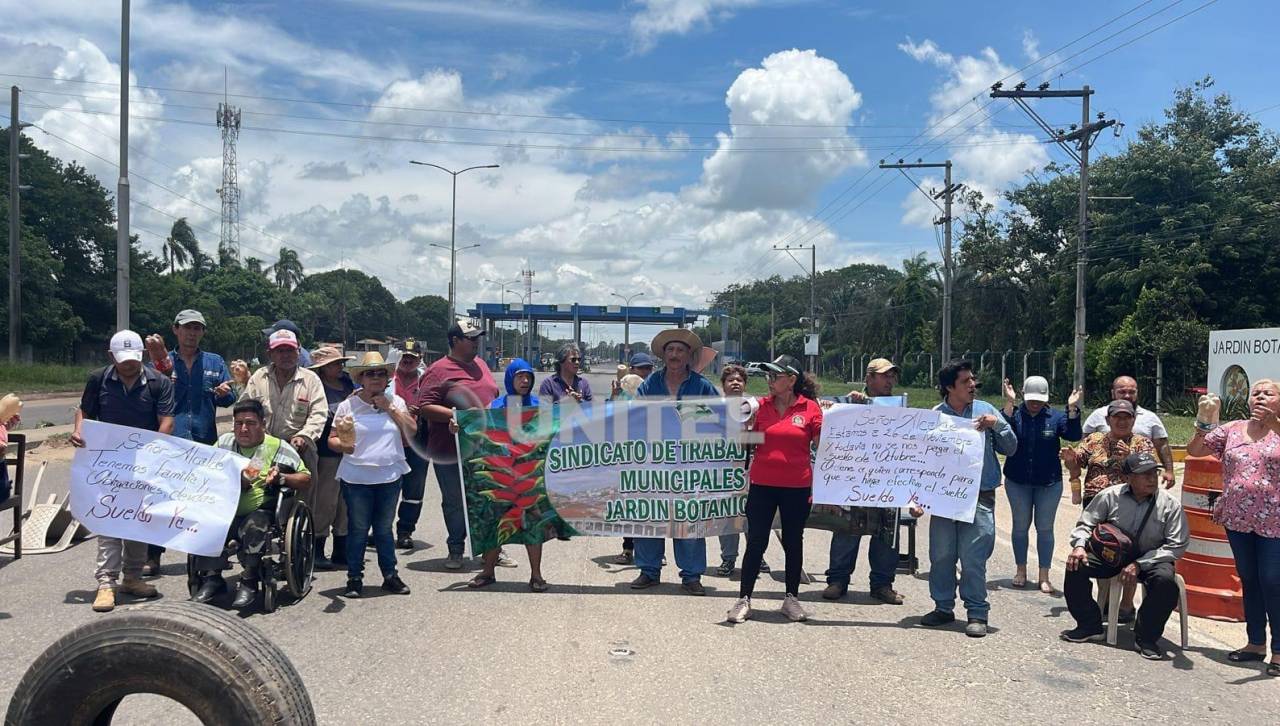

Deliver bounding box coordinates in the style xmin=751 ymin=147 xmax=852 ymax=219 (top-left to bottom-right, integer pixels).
xmin=241 ymin=329 xmax=329 ymax=471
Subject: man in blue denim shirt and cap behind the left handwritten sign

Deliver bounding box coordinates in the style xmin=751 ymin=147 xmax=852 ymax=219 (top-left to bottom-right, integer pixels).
xmin=142 ymin=310 xmax=236 ymax=576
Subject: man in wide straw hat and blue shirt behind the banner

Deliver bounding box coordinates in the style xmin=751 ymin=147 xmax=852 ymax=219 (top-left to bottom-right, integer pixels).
xmin=631 ymin=328 xmax=719 ymax=595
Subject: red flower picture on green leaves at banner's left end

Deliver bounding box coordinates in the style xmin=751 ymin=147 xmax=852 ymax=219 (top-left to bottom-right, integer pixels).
xmin=457 ymin=408 xmax=579 ymax=557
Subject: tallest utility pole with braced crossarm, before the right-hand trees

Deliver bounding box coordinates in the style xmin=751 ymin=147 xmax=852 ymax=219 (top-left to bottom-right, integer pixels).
xmin=991 ymin=82 xmax=1116 ymax=388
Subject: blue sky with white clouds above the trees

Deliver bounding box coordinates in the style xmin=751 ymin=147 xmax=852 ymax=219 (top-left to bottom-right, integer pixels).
xmin=0 ymin=0 xmax=1280 ymax=340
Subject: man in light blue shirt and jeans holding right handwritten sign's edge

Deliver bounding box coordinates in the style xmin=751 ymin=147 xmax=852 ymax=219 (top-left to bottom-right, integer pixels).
xmin=920 ymin=360 xmax=1018 ymax=638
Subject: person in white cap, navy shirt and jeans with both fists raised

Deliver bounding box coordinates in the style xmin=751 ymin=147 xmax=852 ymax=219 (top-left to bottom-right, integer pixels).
xmin=1001 ymin=375 xmax=1083 ymax=595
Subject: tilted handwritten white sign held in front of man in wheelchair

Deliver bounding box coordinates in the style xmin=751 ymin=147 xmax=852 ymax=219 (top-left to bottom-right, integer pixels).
xmin=70 ymin=421 xmax=248 ymax=556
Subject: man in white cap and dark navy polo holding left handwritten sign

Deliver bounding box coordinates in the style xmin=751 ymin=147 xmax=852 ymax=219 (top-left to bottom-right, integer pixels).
xmin=70 ymin=330 xmax=173 ymax=612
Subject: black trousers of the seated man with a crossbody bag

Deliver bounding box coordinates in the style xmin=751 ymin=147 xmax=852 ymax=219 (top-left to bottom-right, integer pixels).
xmin=1062 ymin=554 xmax=1178 ymax=645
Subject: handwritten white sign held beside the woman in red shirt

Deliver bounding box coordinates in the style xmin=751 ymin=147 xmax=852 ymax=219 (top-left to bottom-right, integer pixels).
xmin=813 ymin=406 xmax=984 ymax=521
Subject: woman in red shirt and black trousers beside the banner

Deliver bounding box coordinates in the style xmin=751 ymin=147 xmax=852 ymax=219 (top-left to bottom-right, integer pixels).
xmin=728 ymin=356 xmax=822 ymax=622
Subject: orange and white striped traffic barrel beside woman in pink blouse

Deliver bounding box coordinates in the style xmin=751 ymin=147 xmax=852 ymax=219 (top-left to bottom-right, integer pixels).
xmin=1178 ymin=456 xmax=1244 ymax=622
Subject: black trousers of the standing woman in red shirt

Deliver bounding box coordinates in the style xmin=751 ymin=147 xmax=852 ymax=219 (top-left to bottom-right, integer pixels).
xmin=739 ymin=484 xmax=812 ymax=598
